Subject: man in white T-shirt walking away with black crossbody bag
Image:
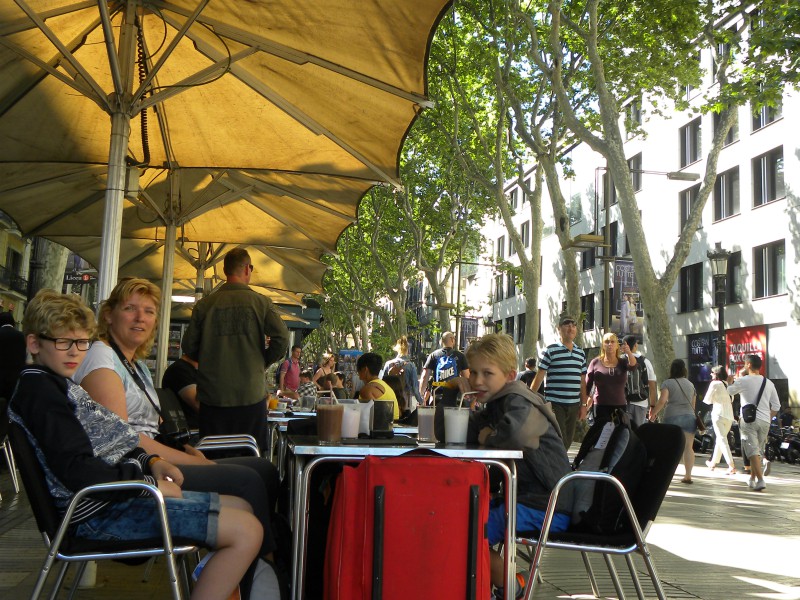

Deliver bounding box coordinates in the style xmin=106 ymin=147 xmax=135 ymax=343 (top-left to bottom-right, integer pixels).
xmin=728 ymin=354 xmax=781 ymax=492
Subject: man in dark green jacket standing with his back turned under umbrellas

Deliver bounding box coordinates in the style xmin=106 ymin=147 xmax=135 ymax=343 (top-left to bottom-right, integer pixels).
xmin=182 ymin=248 xmax=289 ymax=446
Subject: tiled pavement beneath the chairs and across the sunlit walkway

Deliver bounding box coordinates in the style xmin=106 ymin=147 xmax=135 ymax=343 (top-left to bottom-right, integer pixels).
xmin=0 ymin=455 xmax=800 ymax=600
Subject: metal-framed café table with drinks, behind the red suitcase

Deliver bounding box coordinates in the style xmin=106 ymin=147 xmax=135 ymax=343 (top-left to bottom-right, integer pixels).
xmin=287 ymin=435 xmax=522 ymax=600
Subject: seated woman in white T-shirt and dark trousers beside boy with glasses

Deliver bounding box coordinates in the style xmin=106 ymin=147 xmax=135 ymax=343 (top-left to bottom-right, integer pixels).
xmin=74 ymin=277 xmax=278 ymax=559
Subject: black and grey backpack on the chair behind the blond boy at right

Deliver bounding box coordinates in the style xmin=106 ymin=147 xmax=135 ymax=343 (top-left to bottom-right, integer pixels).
xmin=570 ymin=408 xmax=647 ymax=534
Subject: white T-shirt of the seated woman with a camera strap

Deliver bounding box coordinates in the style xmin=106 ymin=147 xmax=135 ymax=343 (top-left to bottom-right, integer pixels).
xmin=72 ymin=341 xmax=161 ymax=438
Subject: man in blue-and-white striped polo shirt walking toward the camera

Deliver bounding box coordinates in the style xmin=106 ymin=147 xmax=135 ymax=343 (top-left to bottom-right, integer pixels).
xmin=531 ymin=316 xmax=588 ymax=449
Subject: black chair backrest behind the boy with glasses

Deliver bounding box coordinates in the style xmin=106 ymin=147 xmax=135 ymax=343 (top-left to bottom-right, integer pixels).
xmin=8 ymin=423 xmax=61 ymax=540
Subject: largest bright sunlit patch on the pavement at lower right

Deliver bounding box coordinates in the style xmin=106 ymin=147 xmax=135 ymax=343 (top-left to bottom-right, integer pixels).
xmin=647 ymin=520 xmax=800 ymax=580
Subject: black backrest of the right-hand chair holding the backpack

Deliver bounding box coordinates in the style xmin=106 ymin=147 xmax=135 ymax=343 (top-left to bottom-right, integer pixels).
xmin=631 ymin=423 xmax=686 ymax=528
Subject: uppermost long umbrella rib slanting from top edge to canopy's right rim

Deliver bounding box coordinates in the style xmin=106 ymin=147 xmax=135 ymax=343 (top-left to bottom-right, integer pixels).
xmin=155 ymin=2 xmax=434 ymax=108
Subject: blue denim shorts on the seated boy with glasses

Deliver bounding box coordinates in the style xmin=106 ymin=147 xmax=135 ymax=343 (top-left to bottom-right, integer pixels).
xmin=74 ymin=492 xmax=220 ymax=548
